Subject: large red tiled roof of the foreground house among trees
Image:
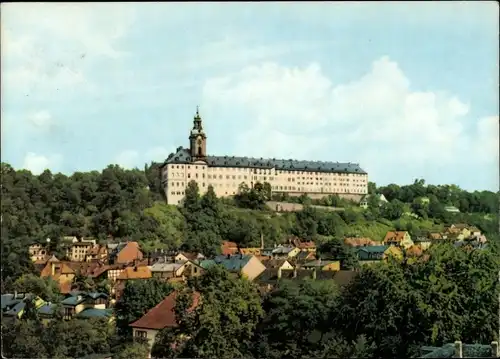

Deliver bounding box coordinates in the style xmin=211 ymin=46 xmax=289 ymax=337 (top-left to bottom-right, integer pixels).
xmin=130 ymin=291 xmax=200 ymax=330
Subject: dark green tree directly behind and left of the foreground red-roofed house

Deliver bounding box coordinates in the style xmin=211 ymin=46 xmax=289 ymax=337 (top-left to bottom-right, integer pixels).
xmin=115 ymin=278 xmax=172 ymax=337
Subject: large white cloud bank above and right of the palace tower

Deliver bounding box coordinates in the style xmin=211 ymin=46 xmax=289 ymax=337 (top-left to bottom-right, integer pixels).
xmin=203 ymin=57 xmax=498 ymax=186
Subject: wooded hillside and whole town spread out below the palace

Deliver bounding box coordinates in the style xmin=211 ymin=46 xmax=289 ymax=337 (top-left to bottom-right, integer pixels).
xmin=1 ymin=163 xmax=500 ymax=359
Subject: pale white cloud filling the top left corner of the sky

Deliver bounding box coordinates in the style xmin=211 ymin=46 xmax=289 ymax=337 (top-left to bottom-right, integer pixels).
xmin=2 ymin=3 xmax=134 ymax=96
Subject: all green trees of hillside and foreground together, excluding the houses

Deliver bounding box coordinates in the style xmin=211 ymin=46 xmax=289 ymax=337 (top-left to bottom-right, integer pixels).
xmin=1 ymin=163 xmax=500 ymax=359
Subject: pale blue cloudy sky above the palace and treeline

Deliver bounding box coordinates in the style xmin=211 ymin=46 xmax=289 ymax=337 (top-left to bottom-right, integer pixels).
xmin=1 ymin=1 xmax=499 ymax=191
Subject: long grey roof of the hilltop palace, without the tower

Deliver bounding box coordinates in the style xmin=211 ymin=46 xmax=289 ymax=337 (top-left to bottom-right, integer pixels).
xmin=163 ymin=147 xmax=366 ymax=174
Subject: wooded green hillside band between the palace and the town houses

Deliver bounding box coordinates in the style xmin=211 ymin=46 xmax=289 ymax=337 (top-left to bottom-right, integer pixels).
xmin=1 ymin=163 xmax=499 ymax=281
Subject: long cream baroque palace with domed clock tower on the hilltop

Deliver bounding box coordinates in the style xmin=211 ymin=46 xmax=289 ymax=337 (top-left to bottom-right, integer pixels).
xmin=161 ymin=109 xmax=368 ymax=204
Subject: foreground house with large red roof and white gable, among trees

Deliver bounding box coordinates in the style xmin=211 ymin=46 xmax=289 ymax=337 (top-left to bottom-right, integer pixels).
xmin=130 ymin=291 xmax=200 ymax=357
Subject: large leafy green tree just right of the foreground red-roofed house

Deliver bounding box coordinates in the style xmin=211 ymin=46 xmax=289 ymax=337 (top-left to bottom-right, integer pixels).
xmin=163 ymin=266 xmax=263 ymax=358
